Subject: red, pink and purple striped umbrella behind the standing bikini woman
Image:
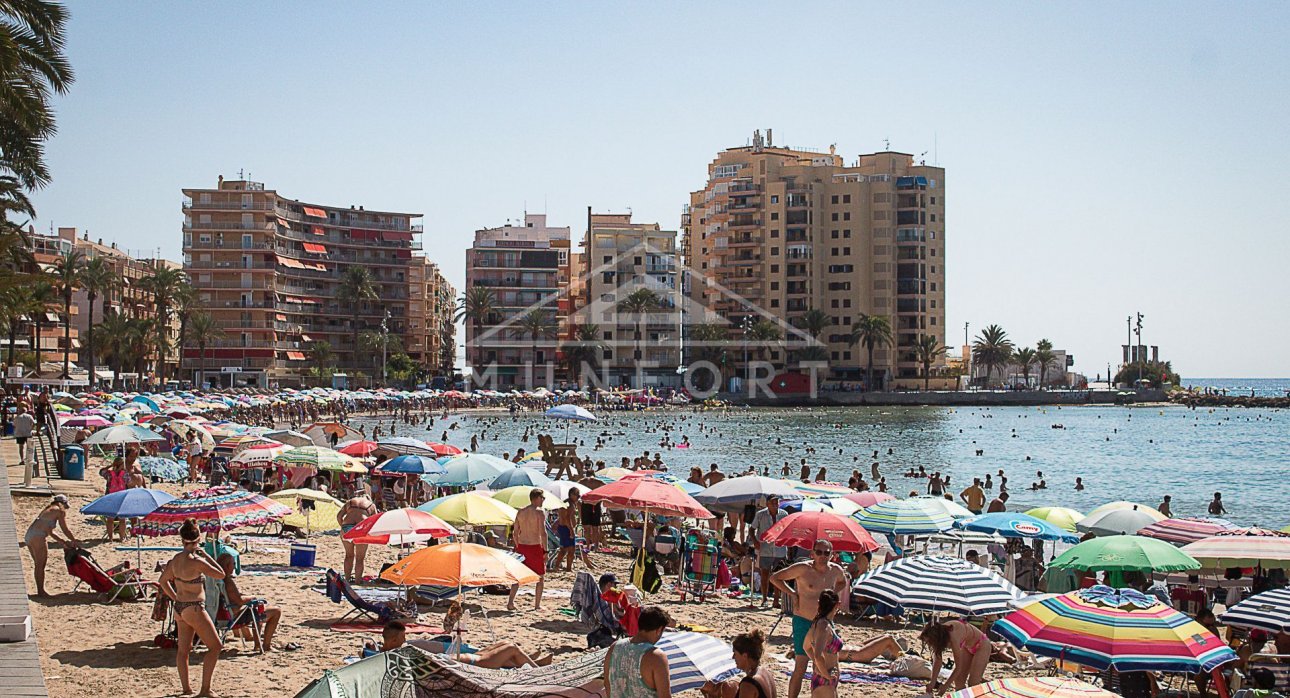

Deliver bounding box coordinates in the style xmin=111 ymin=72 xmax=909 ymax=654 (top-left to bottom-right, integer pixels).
xmin=134 ymin=486 xmax=292 ymax=535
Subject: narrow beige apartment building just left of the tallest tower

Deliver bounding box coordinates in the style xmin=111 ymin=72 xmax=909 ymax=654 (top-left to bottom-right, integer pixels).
xmin=580 ymin=209 xmax=681 ymax=387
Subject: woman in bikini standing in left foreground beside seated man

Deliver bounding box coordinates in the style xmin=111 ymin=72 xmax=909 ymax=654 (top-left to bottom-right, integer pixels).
xmin=160 ymin=519 xmax=224 ymax=697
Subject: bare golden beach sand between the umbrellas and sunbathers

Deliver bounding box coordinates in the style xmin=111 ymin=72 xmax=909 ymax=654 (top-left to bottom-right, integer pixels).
xmin=10 ymin=466 xmax=1037 ymax=698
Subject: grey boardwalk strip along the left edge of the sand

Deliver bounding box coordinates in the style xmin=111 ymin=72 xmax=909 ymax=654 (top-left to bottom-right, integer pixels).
xmin=0 ymin=439 xmax=48 ymax=698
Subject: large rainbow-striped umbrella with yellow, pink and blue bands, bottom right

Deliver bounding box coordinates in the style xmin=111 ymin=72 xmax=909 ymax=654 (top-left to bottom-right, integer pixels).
xmin=993 ymin=584 xmax=1237 ymax=673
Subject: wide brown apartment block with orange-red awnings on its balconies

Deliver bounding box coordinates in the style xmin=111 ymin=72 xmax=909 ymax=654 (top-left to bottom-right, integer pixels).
xmin=183 ymin=177 xmax=450 ymax=386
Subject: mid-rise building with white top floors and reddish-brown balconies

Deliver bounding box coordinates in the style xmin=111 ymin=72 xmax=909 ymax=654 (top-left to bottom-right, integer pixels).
xmin=466 ymin=213 xmax=570 ymax=390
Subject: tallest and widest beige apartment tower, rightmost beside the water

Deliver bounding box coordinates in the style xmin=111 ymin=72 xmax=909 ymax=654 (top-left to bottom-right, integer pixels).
xmin=681 ymin=130 xmax=946 ymax=387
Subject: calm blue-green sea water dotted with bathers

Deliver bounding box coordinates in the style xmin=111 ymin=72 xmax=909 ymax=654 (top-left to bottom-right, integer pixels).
xmin=356 ymin=399 xmax=1290 ymax=528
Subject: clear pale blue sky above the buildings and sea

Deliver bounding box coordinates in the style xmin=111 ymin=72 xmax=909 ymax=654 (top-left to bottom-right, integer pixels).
xmin=22 ymin=1 xmax=1290 ymax=379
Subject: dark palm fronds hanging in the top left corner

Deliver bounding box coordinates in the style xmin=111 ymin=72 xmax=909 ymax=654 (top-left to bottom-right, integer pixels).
xmin=0 ymin=0 xmax=72 ymax=188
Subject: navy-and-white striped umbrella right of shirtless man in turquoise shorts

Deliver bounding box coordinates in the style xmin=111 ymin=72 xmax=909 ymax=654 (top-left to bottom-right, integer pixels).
xmin=851 ymin=555 xmax=1024 ymax=615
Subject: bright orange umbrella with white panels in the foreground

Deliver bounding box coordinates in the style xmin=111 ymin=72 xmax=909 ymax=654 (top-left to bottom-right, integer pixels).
xmin=381 ymin=543 xmax=541 ymax=588
